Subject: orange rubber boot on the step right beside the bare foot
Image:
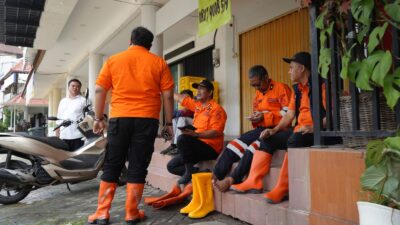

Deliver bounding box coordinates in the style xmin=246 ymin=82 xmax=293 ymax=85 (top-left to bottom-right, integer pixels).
xmin=231 ymin=150 xmax=272 ymax=193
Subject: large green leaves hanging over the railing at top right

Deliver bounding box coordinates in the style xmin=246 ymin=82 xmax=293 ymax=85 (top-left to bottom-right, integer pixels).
xmin=303 ymin=0 xmax=400 ymax=109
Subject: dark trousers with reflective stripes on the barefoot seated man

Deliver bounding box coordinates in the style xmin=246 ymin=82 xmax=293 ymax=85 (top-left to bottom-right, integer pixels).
xmin=213 ymin=127 xmax=265 ymax=183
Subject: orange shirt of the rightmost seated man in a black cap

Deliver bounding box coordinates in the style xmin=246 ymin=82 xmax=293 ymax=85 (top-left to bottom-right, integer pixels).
xmin=289 ymin=83 xmax=326 ymax=132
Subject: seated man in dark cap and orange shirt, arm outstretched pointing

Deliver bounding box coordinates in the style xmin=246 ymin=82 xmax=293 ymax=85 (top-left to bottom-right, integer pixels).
xmin=173 ymin=80 xmax=226 ymax=184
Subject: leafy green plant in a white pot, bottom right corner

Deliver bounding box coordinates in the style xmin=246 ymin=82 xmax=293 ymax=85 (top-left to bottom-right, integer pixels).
xmin=357 ymin=135 xmax=400 ymax=225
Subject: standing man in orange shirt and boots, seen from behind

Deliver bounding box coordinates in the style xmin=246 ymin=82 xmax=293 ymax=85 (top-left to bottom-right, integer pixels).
xmin=88 ymin=27 xmax=174 ymax=225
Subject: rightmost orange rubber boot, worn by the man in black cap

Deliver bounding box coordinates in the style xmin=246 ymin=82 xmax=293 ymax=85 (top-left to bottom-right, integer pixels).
xmin=264 ymin=152 xmax=289 ymax=204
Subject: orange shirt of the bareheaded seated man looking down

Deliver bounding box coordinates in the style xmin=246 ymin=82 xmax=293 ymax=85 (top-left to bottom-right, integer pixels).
xmin=253 ymin=80 xmax=291 ymax=127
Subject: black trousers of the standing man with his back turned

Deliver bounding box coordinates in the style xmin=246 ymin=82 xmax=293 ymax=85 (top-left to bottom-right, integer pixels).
xmin=101 ymin=118 xmax=158 ymax=183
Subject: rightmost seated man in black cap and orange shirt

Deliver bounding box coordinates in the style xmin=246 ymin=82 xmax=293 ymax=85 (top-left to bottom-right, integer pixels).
xmin=256 ymin=52 xmax=340 ymax=203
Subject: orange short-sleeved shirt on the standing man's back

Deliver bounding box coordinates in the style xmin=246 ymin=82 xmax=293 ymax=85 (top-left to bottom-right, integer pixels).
xmin=96 ymin=46 xmax=174 ymax=119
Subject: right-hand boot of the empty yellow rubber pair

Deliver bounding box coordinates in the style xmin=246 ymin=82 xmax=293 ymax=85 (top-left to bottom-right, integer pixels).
xmin=189 ymin=173 xmax=215 ymax=219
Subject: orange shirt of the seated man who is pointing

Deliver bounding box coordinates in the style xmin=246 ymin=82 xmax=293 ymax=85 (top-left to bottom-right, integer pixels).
xmin=182 ymin=97 xmax=226 ymax=154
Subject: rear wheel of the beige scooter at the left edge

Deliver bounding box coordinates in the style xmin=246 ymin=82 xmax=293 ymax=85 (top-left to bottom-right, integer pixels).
xmin=0 ymin=160 xmax=32 ymax=205
